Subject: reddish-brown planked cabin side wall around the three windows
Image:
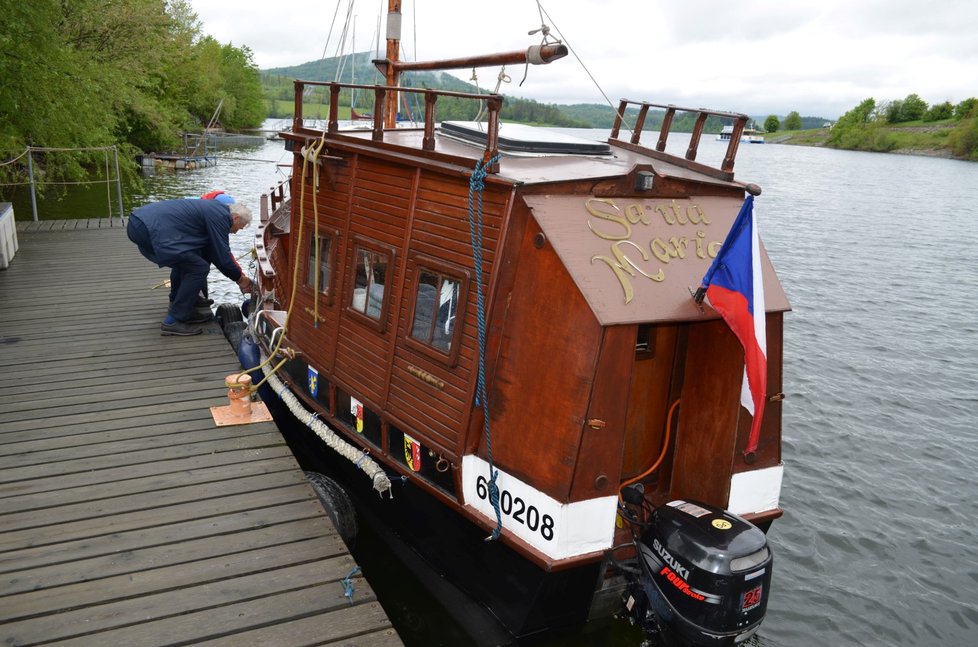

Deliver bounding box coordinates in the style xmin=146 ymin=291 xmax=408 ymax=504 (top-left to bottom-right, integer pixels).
xmin=277 ymin=146 xmax=510 ymax=462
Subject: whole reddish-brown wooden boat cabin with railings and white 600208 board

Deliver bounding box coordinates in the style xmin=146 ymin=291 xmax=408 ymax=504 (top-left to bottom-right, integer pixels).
xmin=250 ymin=82 xmax=788 ymax=636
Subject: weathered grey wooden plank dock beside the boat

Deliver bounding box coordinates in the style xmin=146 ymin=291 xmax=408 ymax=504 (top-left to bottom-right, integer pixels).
xmin=0 ymin=219 xmax=401 ymax=646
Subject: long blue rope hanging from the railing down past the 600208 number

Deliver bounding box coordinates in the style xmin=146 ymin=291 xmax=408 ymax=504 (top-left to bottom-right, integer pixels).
xmin=469 ymin=155 xmax=503 ymax=541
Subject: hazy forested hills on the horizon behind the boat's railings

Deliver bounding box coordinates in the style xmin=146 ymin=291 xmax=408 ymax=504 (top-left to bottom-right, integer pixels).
xmin=261 ymin=52 xmax=808 ymax=133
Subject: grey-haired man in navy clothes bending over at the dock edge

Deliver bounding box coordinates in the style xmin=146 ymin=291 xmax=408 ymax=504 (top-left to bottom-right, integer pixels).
xmin=126 ymin=200 xmax=251 ymax=335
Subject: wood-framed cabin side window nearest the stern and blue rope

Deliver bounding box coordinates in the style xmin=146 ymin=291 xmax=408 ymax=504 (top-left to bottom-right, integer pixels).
xmin=409 ymin=257 xmax=468 ymax=363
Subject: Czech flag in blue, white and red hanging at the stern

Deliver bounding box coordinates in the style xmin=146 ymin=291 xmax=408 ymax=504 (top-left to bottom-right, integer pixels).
xmin=696 ymin=195 xmax=767 ymax=455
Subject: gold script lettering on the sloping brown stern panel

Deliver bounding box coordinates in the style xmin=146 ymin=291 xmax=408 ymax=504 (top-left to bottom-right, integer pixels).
xmin=584 ymin=198 xmax=722 ymax=304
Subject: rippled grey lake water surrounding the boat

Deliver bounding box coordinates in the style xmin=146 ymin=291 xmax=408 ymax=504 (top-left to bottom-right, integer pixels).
xmin=38 ymin=124 xmax=978 ymax=647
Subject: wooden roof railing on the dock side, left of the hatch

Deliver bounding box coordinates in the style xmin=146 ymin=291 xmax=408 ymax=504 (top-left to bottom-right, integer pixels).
xmin=292 ymin=80 xmax=503 ymax=173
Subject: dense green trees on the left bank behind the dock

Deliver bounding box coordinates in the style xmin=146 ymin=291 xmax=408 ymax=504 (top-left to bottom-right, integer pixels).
xmin=0 ymin=0 xmax=264 ymax=195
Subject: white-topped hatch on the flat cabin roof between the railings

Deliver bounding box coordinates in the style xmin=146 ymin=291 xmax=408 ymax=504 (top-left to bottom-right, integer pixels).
xmin=441 ymin=121 xmax=611 ymax=155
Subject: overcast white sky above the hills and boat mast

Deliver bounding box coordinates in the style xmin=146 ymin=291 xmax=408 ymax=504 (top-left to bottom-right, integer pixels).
xmin=189 ymin=0 xmax=978 ymax=118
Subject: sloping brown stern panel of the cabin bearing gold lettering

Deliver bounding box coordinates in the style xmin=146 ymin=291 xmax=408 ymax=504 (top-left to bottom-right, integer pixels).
xmin=523 ymin=195 xmax=790 ymax=326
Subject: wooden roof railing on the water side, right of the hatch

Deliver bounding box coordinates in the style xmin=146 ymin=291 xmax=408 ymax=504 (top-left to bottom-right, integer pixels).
xmin=608 ymin=99 xmax=748 ymax=180
